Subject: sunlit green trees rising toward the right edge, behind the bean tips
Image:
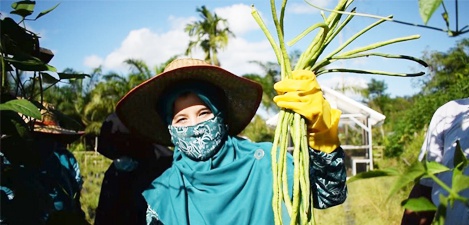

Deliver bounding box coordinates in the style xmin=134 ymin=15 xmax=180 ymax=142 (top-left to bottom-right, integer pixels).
xmin=385 ymin=39 xmax=469 ymax=157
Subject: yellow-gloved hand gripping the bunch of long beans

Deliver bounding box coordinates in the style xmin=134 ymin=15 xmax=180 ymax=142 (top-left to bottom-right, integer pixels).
xmin=274 ymin=70 xmax=342 ymax=153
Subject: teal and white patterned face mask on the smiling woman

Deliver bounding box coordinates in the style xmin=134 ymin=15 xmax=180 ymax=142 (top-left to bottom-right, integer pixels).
xmin=168 ymin=116 xmax=228 ymax=161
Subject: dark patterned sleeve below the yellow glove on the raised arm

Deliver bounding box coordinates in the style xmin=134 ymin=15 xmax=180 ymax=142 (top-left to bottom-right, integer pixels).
xmin=309 ymin=147 xmax=347 ymax=209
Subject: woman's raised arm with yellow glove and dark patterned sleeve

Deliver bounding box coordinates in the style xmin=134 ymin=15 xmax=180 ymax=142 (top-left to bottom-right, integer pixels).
xmin=274 ymin=70 xmax=347 ymax=208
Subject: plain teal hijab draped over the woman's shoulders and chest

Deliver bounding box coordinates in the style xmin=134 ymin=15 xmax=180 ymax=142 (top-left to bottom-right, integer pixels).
xmin=143 ymin=84 xmax=293 ymax=225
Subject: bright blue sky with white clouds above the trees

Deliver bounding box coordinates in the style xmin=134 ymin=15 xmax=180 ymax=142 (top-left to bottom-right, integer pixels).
xmin=0 ymin=0 xmax=469 ymax=99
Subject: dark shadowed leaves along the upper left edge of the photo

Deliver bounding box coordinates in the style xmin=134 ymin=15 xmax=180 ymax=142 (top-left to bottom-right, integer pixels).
xmin=0 ymin=1 xmax=87 ymax=141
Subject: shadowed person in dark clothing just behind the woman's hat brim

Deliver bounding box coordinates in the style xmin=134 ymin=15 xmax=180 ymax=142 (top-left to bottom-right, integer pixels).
xmin=94 ymin=114 xmax=173 ymax=225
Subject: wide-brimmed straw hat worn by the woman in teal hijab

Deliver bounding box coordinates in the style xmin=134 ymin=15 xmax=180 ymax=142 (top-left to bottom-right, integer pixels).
xmin=116 ymin=58 xmax=262 ymax=146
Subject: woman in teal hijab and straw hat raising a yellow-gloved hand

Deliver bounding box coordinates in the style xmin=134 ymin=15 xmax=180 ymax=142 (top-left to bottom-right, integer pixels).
xmin=116 ymin=59 xmax=347 ymax=225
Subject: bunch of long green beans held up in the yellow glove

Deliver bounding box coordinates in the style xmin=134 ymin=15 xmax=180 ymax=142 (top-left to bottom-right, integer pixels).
xmin=252 ymin=0 xmax=427 ymax=225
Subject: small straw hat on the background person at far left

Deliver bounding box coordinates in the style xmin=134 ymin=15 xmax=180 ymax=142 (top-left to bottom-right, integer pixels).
xmin=31 ymin=103 xmax=85 ymax=142
